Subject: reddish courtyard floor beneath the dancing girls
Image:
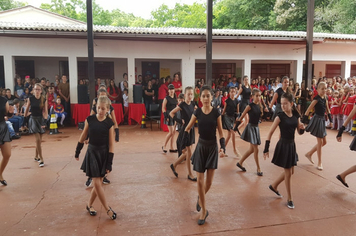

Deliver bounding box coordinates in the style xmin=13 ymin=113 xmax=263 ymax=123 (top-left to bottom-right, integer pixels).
xmin=0 ymin=123 xmax=356 ymax=236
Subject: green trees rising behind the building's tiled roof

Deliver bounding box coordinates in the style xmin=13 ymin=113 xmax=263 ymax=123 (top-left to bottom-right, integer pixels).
xmin=0 ymin=0 xmax=356 ymax=34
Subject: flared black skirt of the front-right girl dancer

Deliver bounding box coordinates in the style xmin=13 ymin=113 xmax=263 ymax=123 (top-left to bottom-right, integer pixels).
xmin=272 ymin=138 xmax=298 ymax=169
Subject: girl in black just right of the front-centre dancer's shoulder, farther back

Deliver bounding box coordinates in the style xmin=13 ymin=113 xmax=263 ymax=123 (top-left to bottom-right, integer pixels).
xmin=222 ymin=87 xmax=240 ymax=156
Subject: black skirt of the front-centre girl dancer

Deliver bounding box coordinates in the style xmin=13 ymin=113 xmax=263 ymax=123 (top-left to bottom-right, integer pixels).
xmin=191 ymin=138 xmax=219 ymax=173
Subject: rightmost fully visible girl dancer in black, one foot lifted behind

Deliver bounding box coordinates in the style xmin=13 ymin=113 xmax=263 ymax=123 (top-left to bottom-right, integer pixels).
xmin=303 ymin=82 xmax=332 ymax=170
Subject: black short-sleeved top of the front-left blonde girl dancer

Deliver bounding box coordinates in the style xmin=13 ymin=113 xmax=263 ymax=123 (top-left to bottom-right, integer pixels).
xmin=87 ymin=115 xmax=114 ymax=146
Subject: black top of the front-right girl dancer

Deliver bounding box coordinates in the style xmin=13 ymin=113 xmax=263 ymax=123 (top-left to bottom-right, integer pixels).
xmin=277 ymin=111 xmax=299 ymax=140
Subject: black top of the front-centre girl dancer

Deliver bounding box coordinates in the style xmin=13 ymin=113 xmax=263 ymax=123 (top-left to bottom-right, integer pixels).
xmin=194 ymin=107 xmax=220 ymax=140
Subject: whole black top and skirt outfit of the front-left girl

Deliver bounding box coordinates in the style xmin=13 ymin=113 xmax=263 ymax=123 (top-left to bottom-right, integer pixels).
xmin=80 ymin=115 xmax=114 ymax=178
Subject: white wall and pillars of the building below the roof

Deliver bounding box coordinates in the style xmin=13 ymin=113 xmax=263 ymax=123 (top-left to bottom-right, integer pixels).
xmin=0 ymin=37 xmax=356 ymax=103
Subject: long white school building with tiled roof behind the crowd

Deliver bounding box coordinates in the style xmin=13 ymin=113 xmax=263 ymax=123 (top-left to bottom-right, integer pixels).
xmin=0 ymin=6 xmax=356 ymax=104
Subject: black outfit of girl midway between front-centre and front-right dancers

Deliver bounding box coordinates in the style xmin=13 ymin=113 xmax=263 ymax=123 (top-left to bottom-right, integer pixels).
xmin=241 ymin=102 xmax=261 ymax=145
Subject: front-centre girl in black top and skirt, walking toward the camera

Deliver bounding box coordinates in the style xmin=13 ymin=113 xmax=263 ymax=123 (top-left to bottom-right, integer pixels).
xmin=184 ymin=86 xmax=225 ymax=225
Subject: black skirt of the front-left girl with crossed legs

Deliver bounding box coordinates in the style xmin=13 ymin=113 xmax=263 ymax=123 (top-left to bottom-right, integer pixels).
xmin=80 ymin=144 xmax=109 ymax=178
